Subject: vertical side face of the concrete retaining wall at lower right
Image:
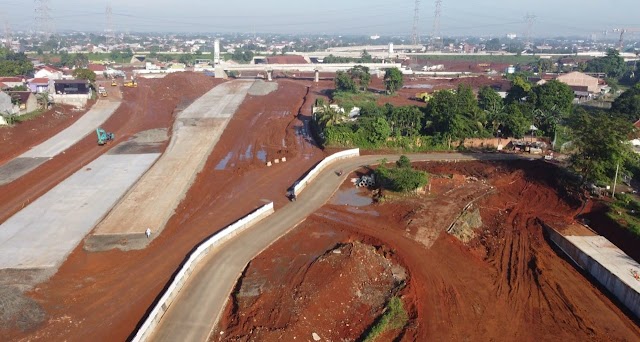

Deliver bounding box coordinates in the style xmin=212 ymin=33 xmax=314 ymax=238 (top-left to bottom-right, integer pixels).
xmin=545 ymin=226 xmax=640 ymax=318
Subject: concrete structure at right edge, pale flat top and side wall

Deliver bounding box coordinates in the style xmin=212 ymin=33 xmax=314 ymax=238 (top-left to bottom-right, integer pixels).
xmin=544 ymin=226 xmax=640 ymax=318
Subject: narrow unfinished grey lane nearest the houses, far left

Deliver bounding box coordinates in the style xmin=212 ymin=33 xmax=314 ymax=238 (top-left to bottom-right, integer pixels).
xmin=0 ymin=100 xmax=120 ymax=185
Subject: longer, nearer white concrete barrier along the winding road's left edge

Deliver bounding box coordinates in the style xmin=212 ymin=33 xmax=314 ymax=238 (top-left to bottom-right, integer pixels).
xmin=132 ymin=202 xmax=274 ymax=342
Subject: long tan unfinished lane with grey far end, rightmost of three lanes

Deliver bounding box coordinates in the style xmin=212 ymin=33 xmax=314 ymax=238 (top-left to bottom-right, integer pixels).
xmin=85 ymin=80 xmax=257 ymax=251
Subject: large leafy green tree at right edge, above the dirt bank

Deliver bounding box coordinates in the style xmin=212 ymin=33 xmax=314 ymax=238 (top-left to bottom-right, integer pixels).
xmin=569 ymin=109 xmax=633 ymax=184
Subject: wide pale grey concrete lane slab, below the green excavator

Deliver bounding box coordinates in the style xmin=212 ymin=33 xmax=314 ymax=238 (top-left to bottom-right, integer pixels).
xmin=0 ymin=142 xmax=160 ymax=269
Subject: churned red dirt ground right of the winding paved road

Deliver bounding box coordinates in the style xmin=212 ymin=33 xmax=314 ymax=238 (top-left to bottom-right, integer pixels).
xmin=212 ymin=161 xmax=640 ymax=341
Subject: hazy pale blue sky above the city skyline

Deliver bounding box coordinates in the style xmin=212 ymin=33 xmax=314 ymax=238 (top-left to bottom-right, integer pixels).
xmin=0 ymin=0 xmax=640 ymax=37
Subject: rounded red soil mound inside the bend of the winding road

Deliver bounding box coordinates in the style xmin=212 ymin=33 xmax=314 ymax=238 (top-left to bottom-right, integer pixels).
xmin=212 ymin=236 xmax=407 ymax=341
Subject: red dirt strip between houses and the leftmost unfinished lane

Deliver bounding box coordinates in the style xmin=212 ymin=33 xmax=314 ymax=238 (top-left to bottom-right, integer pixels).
xmin=0 ymin=100 xmax=95 ymax=165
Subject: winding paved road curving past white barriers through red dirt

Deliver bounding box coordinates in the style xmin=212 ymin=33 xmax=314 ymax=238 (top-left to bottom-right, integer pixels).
xmin=150 ymin=153 xmax=537 ymax=342
